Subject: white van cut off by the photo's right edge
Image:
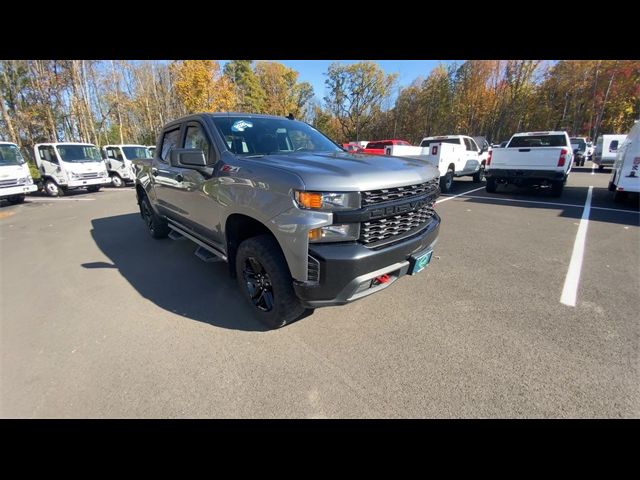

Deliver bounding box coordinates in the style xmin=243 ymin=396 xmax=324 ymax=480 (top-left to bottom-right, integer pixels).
xmin=609 ymin=121 xmax=640 ymax=202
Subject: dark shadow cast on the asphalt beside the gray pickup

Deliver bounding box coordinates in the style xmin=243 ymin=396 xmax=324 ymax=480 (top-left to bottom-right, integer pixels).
xmin=82 ymin=213 xmax=267 ymax=331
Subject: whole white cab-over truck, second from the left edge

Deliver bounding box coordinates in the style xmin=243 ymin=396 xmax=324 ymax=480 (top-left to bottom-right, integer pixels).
xmin=33 ymin=142 xmax=111 ymax=197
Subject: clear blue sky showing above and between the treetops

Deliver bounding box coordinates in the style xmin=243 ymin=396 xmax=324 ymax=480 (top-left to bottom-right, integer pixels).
xmin=220 ymin=60 xmax=451 ymax=101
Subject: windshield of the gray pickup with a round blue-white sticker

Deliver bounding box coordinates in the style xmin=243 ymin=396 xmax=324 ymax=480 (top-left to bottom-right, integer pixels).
xmin=213 ymin=116 xmax=343 ymax=156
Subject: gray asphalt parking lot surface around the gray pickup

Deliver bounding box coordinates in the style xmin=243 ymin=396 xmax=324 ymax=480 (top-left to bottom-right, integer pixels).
xmin=0 ymin=162 xmax=640 ymax=418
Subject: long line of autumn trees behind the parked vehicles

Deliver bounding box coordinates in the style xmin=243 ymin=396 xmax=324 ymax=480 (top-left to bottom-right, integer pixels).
xmin=0 ymin=60 xmax=640 ymax=158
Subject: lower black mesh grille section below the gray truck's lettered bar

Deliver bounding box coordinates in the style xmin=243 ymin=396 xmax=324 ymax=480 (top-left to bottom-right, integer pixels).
xmin=360 ymin=205 xmax=435 ymax=247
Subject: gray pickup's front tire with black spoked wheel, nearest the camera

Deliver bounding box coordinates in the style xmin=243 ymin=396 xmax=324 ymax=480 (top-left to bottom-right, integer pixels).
xmin=235 ymin=235 xmax=305 ymax=329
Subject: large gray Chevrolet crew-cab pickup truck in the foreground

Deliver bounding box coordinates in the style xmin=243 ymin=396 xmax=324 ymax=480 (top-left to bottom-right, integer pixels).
xmin=134 ymin=113 xmax=440 ymax=328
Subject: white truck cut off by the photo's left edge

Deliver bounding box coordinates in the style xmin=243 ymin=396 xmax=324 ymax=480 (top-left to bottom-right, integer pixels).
xmin=0 ymin=142 xmax=38 ymax=204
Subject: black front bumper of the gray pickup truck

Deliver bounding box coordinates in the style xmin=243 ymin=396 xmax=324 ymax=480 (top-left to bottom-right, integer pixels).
xmin=294 ymin=214 xmax=440 ymax=308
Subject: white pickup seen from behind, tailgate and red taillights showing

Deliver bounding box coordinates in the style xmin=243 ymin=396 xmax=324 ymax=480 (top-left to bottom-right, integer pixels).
xmin=485 ymin=131 xmax=573 ymax=197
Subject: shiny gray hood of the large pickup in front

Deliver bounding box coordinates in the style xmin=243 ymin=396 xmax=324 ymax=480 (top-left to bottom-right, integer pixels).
xmin=242 ymin=152 xmax=440 ymax=192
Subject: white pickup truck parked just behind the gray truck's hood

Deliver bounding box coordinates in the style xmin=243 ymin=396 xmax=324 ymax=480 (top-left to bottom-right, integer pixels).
xmin=385 ymin=135 xmax=486 ymax=193
